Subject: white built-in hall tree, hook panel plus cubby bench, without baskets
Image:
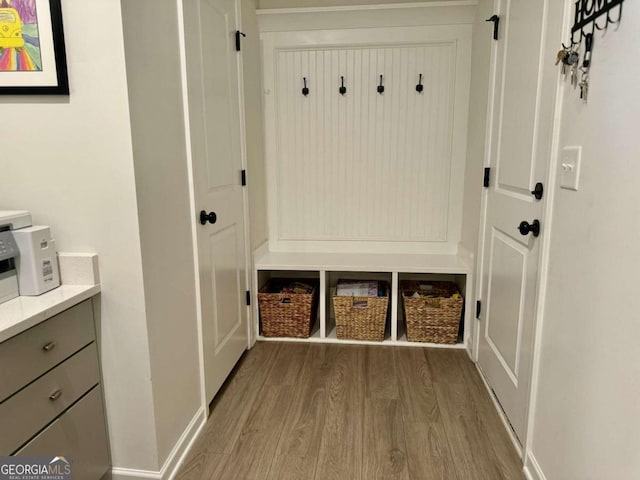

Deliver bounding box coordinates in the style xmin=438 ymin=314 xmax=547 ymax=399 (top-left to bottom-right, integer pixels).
xmin=250 ymin=2 xmax=475 ymax=347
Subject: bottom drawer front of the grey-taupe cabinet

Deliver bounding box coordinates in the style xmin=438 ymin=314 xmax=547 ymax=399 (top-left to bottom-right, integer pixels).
xmin=16 ymin=386 xmax=109 ymax=480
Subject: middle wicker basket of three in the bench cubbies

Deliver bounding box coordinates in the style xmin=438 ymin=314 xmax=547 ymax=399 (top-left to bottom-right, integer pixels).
xmin=333 ymin=282 xmax=389 ymax=342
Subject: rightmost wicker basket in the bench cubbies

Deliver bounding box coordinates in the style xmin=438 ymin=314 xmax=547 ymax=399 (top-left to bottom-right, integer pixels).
xmin=400 ymin=281 xmax=464 ymax=343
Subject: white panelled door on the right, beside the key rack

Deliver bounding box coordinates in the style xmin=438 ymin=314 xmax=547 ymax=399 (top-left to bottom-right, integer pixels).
xmin=478 ymin=0 xmax=555 ymax=442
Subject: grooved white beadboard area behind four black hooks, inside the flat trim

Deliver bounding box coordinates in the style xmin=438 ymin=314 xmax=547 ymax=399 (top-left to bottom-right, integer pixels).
xmin=276 ymin=43 xmax=456 ymax=242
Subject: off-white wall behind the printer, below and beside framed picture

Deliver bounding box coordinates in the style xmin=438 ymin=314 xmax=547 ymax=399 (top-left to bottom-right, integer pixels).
xmin=0 ymin=0 xmax=158 ymax=469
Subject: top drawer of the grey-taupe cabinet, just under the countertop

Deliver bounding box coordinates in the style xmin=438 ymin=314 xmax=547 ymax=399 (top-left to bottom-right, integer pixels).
xmin=0 ymin=300 xmax=95 ymax=401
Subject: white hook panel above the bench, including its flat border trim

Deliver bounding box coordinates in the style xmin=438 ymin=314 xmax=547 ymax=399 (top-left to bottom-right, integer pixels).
xmin=263 ymin=26 xmax=470 ymax=253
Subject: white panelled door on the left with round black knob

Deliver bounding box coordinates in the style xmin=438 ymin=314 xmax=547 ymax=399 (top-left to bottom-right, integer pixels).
xmin=183 ymin=0 xmax=248 ymax=402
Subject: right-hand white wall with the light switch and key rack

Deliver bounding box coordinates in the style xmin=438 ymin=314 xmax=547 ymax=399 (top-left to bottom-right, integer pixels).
xmin=530 ymin=0 xmax=640 ymax=480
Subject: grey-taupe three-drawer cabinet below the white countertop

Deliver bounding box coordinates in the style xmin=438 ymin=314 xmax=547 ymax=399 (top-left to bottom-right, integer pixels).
xmin=0 ymin=299 xmax=110 ymax=480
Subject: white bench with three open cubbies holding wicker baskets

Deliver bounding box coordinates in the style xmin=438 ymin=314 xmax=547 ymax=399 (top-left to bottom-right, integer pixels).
xmin=252 ymin=252 xmax=473 ymax=348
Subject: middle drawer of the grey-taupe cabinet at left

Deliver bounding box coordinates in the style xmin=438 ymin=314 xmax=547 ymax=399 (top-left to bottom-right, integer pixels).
xmin=0 ymin=343 xmax=100 ymax=455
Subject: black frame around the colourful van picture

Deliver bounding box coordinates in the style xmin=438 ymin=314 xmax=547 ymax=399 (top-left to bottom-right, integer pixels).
xmin=0 ymin=0 xmax=69 ymax=95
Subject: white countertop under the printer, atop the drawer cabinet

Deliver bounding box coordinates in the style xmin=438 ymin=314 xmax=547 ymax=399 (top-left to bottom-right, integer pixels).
xmin=0 ymin=285 xmax=100 ymax=342
